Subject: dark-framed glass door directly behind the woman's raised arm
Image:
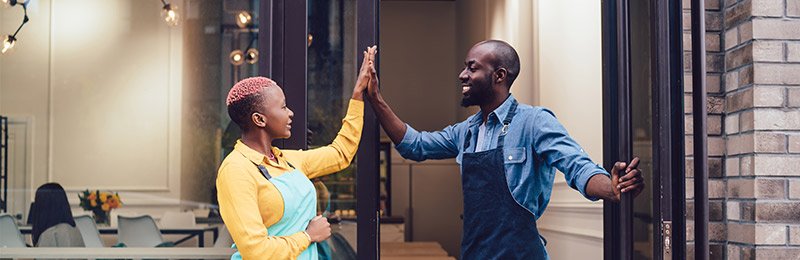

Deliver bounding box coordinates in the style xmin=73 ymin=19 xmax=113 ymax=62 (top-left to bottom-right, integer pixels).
xmin=258 ymin=0 xmax=380 ymax=259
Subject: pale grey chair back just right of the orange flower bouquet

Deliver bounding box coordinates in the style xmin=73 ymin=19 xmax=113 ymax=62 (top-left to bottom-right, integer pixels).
xmin=117 ymin=215 xmax=174 ymax=247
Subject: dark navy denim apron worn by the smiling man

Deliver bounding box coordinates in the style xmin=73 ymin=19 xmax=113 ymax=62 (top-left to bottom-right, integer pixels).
xmin=461 ymin=101 xmax=547 ymax=260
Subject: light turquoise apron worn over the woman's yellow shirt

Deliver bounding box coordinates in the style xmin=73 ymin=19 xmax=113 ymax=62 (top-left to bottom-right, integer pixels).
xmin=231 ymin=159 xmax=319 ymax=260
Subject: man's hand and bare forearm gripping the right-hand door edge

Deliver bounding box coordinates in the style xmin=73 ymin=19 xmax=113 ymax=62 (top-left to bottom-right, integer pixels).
xmin=586 ymin=157 xmax=644 ymax=202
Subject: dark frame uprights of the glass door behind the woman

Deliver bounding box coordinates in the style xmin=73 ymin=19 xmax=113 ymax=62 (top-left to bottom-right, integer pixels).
xmin=258 ymin=0 xmax=380 ymax=259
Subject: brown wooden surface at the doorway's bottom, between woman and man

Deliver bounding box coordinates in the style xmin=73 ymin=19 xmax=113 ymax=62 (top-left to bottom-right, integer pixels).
xmin=381 ymin=242 xmax=455 ymax=260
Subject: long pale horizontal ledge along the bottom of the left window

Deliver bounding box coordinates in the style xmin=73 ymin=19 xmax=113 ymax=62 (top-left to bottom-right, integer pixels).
xmin=0 ymin=247 xmax=236 ymax=259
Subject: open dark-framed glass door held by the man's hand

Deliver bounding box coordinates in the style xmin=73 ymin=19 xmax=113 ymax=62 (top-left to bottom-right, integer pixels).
xmin=603 ymin=0 xmax=686 ymax=259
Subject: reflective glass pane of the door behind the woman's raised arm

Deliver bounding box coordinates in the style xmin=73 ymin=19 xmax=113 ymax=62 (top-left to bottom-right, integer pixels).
xmin=306 ymin=0 xmax=358 ymax=248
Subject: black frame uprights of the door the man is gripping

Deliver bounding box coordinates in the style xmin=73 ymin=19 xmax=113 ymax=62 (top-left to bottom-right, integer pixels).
xmin=602 ymin=0 xmax=686 ymax=260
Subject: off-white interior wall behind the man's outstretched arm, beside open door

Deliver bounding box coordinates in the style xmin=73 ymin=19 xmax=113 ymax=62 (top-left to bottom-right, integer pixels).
xmin=535 ymin=0 xmax=603 ymax=259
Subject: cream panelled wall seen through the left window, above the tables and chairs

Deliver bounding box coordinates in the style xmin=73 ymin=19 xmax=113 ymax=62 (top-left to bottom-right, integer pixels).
xmin=0 ymin=0 xmax=182 ymax=217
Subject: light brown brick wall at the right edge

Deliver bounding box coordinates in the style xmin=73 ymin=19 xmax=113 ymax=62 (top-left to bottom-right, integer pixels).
xmin=684 ymin=0 xmax=800 ymax=260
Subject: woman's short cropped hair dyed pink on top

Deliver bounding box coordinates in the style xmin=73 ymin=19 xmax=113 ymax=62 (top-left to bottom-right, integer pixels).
xmin=225 ymin=77 xmax=278 ymax=131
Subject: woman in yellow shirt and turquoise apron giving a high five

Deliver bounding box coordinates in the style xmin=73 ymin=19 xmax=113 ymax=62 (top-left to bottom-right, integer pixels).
xmin=217 ymin=46 xmax=377 ymax=259
